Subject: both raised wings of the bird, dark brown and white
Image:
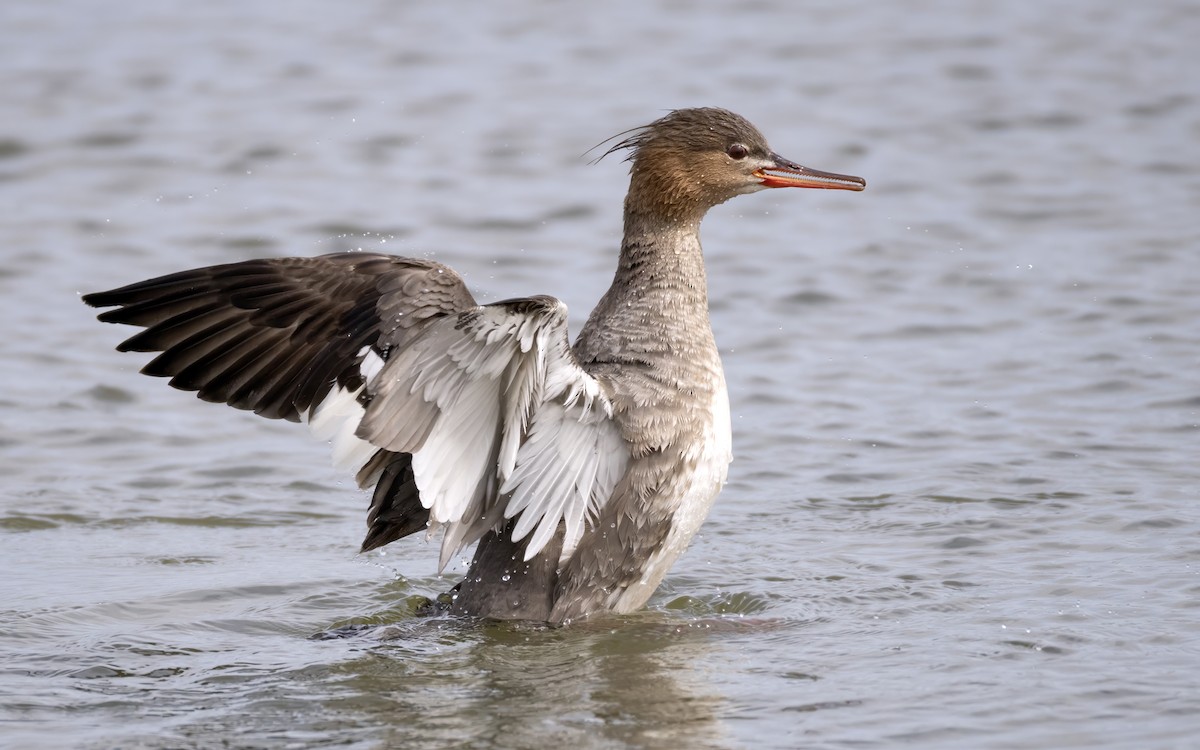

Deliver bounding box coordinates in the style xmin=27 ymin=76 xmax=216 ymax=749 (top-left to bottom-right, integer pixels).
xmin=84 ymin=253 xmax=629 ymax=566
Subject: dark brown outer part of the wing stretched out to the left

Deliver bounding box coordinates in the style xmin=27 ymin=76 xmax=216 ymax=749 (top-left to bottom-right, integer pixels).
xmin=83 ymin=253 xmax=475 ymax=421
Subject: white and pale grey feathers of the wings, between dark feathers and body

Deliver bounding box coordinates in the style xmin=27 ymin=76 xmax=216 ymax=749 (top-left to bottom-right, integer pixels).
xmin=310 ymin=298 xmax=629 ymax=568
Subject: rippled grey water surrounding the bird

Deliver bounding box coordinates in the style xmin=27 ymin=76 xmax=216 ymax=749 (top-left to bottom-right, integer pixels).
xmin=0 ymin=0 xmax=1200 ymax=750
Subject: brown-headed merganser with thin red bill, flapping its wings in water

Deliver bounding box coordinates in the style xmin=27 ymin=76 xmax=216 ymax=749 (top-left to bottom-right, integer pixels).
xmin=83 ymin=107 xmax=866 ymax=626
